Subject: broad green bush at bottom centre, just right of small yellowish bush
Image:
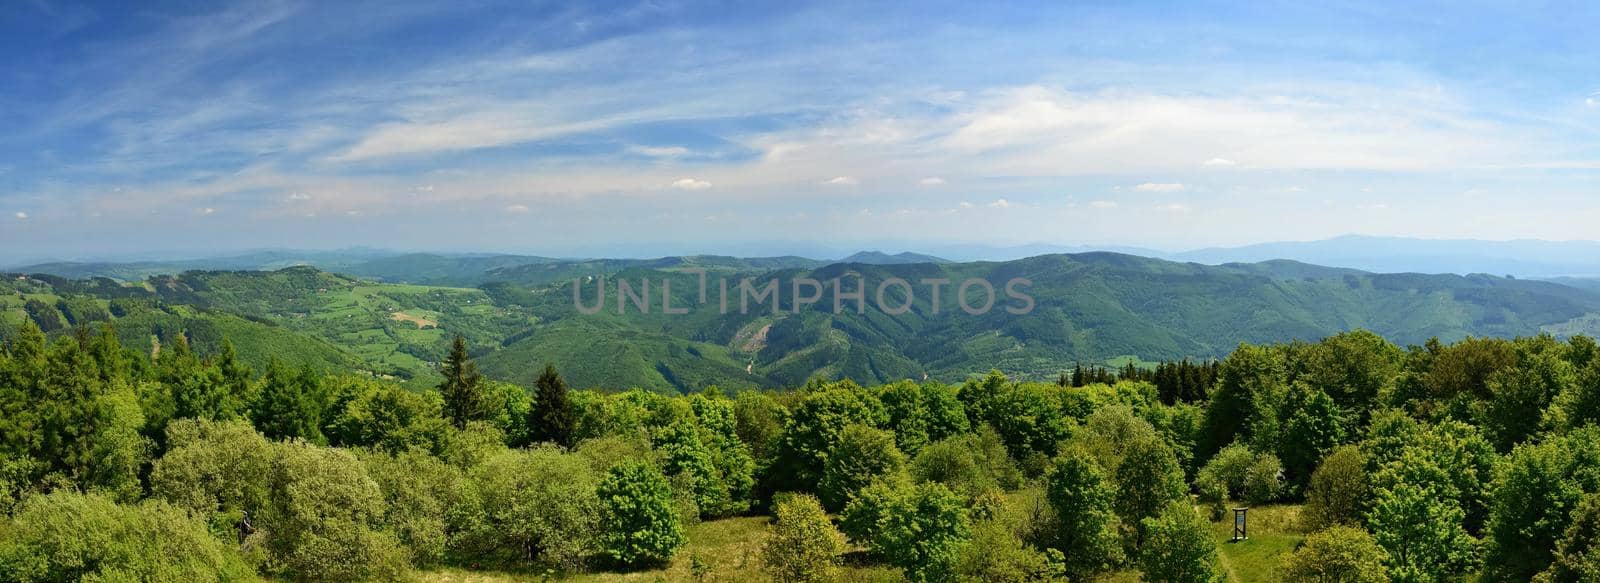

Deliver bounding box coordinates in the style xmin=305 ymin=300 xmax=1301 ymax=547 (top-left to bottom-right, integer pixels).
xmin=842 ymin=482 xmax=971 ymax=581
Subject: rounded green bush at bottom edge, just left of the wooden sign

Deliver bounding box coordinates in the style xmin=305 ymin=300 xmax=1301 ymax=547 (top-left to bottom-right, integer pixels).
xmin=1139 ymin=501 xmax=1218 ymax=583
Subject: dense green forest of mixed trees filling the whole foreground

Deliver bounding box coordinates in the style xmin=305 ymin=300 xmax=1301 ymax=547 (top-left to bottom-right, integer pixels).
xmin=0 ymin=313 xmax=1600 ymax=581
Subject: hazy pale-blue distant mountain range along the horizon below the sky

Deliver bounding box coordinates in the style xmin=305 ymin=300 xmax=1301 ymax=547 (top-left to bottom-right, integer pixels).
xmin=5 ymin=235 xmax=1600 ymax=287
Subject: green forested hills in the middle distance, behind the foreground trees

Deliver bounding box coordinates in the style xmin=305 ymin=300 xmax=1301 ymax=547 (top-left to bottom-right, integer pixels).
xmin=0 ymin=253 xmax=1600 ymax=391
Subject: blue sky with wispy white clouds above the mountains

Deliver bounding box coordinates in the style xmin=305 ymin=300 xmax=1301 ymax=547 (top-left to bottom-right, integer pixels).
xmin=0 ymin=0 xmax=1600 ymax=258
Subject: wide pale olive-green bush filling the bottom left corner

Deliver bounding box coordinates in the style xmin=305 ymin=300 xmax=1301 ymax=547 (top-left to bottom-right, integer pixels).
xmin=0 ymin=492 xmax=256 ymax=581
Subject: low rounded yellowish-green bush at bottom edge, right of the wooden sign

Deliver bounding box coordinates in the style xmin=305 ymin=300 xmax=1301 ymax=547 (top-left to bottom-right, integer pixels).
xmin=1283 ymin=525 xmax=1389 ymax=583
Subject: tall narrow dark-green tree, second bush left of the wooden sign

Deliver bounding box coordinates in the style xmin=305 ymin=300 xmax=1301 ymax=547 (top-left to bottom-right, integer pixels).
xmin=1045 ymin=447 xmax=1122 ymax=580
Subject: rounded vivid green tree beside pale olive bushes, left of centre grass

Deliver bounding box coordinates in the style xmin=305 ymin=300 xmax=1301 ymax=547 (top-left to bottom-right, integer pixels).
xmin=597 ymin=461 xmax=683 ymax=565
